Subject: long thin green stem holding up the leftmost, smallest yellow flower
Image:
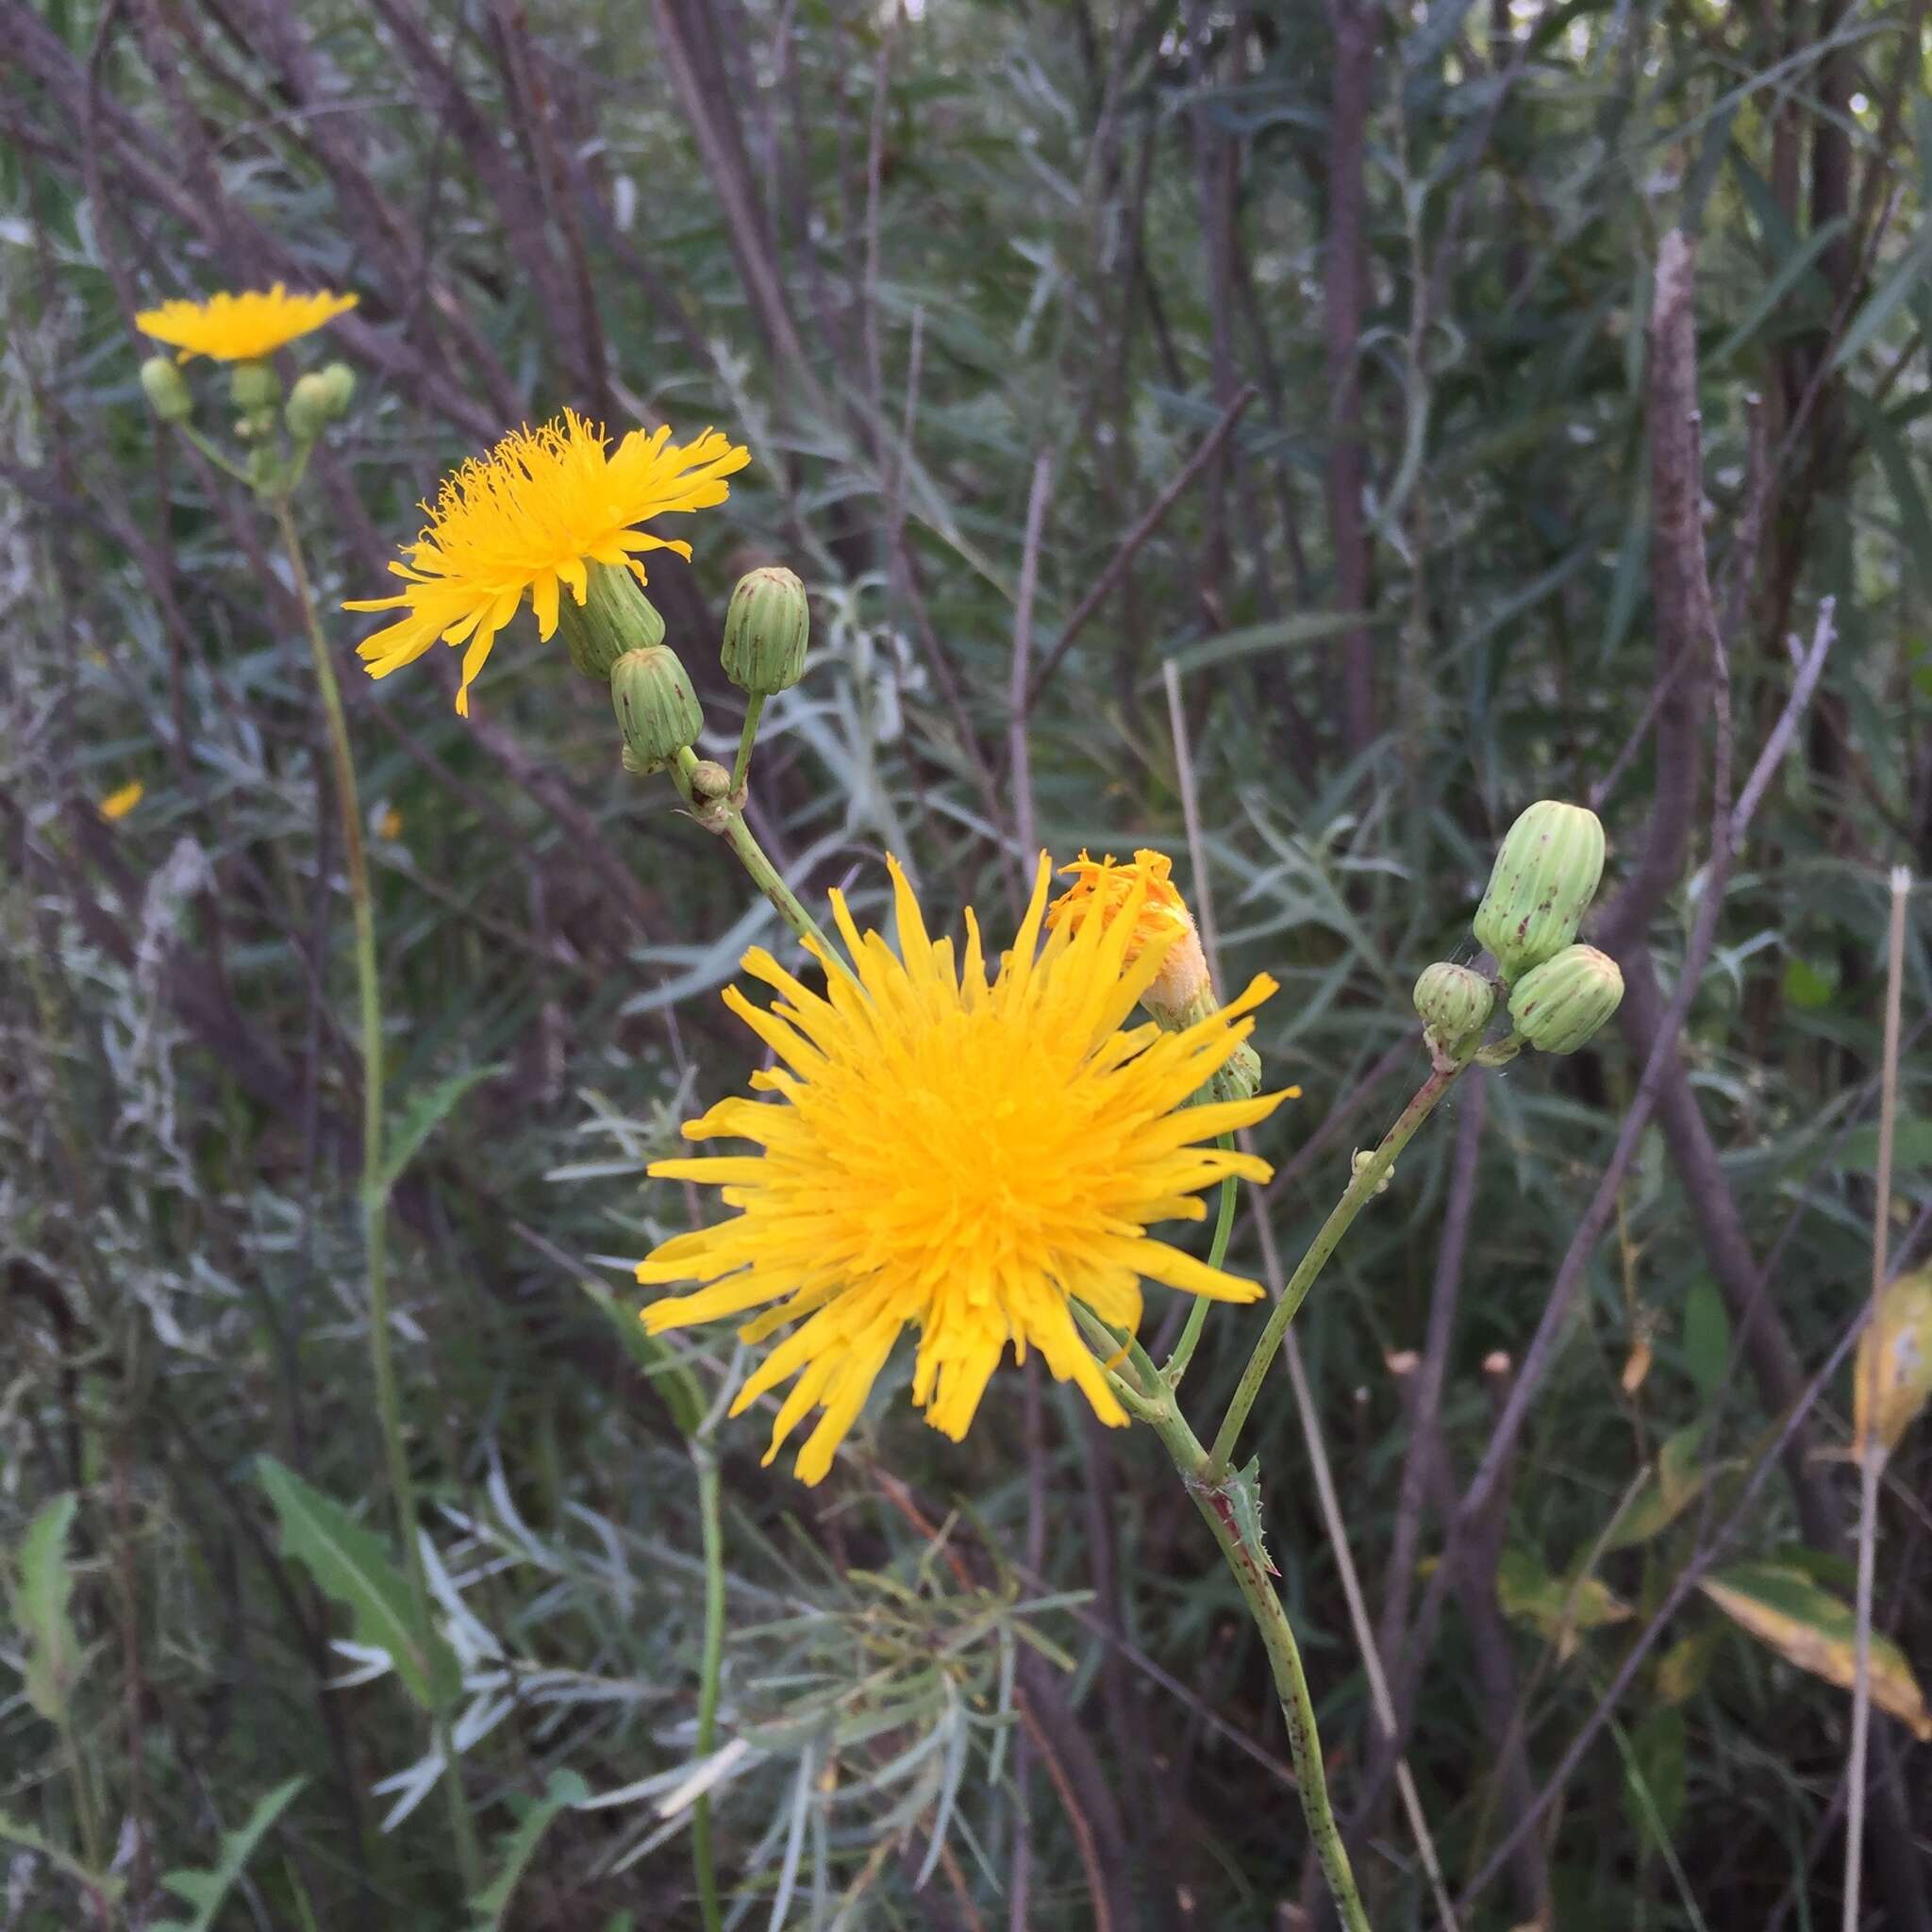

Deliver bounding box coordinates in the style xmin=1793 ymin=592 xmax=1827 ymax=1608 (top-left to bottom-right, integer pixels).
xmin=273 ymin=496 xmax=483 ymax=1897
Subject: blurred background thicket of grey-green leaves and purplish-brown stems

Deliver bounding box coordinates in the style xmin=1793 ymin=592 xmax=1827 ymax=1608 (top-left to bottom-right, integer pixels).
xmin=0 ymin=0 xmax=1932 ymax=1932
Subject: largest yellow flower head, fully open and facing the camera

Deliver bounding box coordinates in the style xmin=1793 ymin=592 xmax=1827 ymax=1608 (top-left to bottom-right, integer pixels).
xmin=638 ymin=854 xmax=1279 ymax=1482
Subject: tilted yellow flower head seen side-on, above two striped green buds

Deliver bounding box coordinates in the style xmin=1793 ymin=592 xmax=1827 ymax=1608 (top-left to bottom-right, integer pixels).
xmin=341 ymin=409 xmax=752 ymax=717
